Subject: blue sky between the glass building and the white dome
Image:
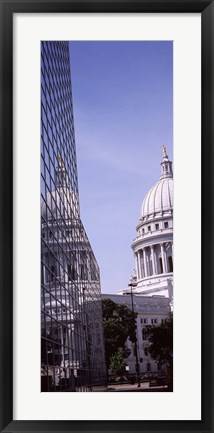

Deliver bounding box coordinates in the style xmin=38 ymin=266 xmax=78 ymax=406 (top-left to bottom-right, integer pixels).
xmin=70 ymin=41 xmax=173 ymax=293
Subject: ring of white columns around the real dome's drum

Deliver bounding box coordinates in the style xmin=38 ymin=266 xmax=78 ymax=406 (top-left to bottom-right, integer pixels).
xmin=135 ymin=242 xmax=173 ymax=279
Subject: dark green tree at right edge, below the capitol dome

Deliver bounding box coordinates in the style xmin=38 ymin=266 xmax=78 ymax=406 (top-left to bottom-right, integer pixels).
xmin=146 ymin=319 xmax=173 ymax=367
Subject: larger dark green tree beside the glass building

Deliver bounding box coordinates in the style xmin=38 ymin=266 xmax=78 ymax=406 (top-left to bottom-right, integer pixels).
xmin=102 ymin=299 xmax=137 ymax=368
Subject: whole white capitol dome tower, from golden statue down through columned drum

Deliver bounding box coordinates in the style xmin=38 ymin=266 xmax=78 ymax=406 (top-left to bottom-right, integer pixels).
xmin=128 ymin=146 xmax=173 ymax=300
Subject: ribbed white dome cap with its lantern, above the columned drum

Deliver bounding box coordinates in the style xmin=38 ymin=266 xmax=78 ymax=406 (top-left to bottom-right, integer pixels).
xmin=141 ymin=153 xmax=173 ymax=220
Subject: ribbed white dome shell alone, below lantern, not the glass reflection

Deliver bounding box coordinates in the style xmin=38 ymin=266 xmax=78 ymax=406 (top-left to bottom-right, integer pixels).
xmin=141 ymin=177 xmax=173 ymax=218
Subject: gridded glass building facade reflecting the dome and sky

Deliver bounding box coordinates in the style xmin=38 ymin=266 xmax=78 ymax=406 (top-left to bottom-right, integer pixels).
xmin=41 ymin=42 xmax=106 ymax=391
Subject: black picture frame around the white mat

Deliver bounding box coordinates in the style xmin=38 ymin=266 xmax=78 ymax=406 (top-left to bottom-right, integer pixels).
xmin=0 ymin=0 xmax=214 ymax=433
